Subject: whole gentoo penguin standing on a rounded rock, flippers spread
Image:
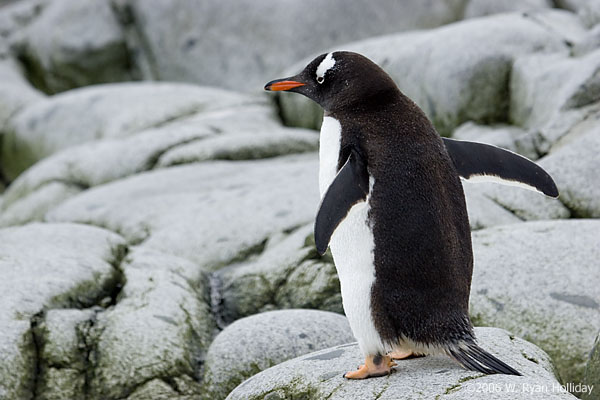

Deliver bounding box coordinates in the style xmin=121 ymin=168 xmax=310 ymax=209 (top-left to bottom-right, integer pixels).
xmin=265 ymin=51 xmax=558 ymax=379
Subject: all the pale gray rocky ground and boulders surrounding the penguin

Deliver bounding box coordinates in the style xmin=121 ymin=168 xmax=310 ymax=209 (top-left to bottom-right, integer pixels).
xmin=0 ymin=0 xmax=600 ymax=400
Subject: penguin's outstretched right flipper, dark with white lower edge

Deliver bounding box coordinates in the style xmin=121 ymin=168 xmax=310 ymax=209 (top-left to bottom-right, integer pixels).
xmin=442 ymin=138 xmax=558 ymax=198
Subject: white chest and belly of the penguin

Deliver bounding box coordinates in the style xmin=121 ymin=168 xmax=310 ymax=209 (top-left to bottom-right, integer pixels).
xmin=319 ymin=117 xmax=389 ymax=356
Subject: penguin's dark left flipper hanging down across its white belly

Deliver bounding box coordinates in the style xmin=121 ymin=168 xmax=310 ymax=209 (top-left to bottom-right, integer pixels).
xmin=315 ymin=150 xmax=369 ymax=255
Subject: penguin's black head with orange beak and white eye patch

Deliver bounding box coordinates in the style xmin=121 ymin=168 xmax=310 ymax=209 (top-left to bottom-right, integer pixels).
xmin=265 ymin=51 xmax=398 ymax=111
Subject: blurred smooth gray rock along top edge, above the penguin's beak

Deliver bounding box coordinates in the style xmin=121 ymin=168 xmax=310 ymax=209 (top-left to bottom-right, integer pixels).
xmin=117 ymin=0 xmax=465 ymax=91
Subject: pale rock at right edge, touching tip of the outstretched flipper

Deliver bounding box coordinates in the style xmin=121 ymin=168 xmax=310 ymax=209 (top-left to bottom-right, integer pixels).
xmin=540 ymin=126 xmax=600 ymax=218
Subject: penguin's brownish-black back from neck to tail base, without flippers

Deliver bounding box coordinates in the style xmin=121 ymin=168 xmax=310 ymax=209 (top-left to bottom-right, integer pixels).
xmin=331 ymin=91 xmax=473 ymax=343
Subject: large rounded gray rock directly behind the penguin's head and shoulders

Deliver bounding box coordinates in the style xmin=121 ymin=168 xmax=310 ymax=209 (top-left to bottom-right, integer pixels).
xmin=280 ymin=11 xmax=579 ymax=135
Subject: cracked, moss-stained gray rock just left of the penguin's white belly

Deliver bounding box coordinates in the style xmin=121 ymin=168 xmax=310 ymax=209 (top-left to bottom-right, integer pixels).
xmin=214 ymin=222 xmax=343 ymax=324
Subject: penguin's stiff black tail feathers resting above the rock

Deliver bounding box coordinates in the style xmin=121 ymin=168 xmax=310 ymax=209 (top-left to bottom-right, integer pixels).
xmin=448 ymin=343 xmax=521 ymax=376
